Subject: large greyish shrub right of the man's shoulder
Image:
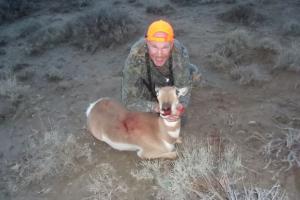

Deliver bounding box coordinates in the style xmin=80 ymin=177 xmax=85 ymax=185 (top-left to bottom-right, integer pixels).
xmin=207 ymin=29 xmax=283 ymax=79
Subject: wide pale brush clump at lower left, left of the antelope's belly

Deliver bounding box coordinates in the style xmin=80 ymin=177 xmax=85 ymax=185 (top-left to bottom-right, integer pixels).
xmin=7 ymin=121 xmax=91 ymax=193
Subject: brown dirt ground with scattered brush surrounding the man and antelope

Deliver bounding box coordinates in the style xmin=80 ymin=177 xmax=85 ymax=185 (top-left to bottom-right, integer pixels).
xmin=0 ymin=0 xmax=300 ymax=200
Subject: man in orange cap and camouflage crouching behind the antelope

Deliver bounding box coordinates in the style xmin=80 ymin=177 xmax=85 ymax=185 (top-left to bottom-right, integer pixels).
xmin=122 ymin=20 xmax=198 ymax=116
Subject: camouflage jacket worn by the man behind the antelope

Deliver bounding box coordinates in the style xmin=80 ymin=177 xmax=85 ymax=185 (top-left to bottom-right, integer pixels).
xmin=122 ymin=38 xmax=192 ymax=111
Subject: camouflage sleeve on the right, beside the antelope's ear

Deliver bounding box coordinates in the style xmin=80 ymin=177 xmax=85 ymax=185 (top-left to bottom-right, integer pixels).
xmin=173 ymin=42 xmax=192 ymax=108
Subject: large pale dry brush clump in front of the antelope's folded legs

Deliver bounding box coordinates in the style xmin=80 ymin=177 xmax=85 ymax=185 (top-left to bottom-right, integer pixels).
xmin=132 ymin=138 xmax=287 ymax=200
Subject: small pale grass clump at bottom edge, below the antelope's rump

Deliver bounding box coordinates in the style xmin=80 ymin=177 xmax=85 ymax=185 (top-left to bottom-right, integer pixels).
xmin=83 ymin=164 xmax=128 ymax=200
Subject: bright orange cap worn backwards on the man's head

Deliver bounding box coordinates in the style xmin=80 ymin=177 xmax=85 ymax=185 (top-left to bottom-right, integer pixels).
xmin=146 ymin=20 xmax=174 ymax=42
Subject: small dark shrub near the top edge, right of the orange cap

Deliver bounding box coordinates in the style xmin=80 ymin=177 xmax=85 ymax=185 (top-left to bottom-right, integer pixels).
xmin=218 ymin=4 xmax=264 ymax=26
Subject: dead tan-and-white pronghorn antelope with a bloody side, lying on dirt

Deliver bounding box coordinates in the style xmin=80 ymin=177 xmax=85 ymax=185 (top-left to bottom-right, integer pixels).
xmin=86 ymin=86 xmax=188 ymax=159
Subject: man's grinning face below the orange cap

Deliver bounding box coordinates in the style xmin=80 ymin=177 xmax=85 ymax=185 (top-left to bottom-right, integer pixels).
xmin=147 ymin=41 xmax=173 ymax=67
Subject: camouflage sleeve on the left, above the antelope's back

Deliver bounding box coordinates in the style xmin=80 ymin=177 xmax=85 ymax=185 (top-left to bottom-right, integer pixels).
xmin=122 ymin=42 xmax=156 ymax=112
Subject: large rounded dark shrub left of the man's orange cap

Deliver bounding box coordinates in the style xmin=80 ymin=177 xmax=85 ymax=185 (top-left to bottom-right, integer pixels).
xmin=71 ymin=8 xmax=136 ymax=51
